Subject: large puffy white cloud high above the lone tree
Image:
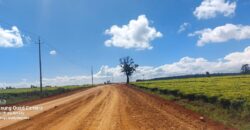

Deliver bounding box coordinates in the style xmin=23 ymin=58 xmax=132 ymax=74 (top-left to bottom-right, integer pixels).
xmin=105 ymin=15 xmax=162 ymax=50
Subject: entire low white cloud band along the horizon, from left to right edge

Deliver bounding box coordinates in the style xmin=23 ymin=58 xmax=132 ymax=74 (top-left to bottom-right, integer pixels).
xmin=0 ymin=46 xmax=250 ymax=87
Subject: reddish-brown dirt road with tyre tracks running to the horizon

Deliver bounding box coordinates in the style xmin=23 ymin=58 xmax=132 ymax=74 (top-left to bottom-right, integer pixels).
xmin=0 ymin=85 xmax=230 ymax=130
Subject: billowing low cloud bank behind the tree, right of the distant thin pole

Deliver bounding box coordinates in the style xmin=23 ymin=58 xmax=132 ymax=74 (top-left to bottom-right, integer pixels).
xmin=88 ymin=46 xmax=250 ymax=81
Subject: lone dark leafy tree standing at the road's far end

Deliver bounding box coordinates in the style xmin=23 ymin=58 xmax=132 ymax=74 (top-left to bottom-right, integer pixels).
xmin=120 ymin=56 xmax=139 ymax=84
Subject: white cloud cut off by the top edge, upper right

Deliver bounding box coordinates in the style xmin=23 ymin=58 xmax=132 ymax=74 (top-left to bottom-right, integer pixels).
xmin=193 ymin=0 xmax=237 ymax=19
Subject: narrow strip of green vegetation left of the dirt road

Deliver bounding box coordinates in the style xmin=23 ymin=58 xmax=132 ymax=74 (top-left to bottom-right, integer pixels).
xmin=0 ymin=85 xmax=89 ymax=105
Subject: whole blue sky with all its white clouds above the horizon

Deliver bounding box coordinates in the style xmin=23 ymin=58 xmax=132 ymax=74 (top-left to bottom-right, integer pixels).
xmin=0 ymin=0 xmax=250 ymax=87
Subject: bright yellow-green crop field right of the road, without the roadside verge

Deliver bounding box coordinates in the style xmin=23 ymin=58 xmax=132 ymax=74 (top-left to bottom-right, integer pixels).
xmin=133 ymin=75 xmax=250 ymax=109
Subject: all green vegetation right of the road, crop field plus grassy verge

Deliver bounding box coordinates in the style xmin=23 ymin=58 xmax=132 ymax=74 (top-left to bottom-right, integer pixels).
xmin=132 ymin=75 xmax=250 ymax=129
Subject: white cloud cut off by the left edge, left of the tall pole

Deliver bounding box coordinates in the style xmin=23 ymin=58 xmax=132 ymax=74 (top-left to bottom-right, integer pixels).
xmin=0 ymin=26 xmax=23 ymax=48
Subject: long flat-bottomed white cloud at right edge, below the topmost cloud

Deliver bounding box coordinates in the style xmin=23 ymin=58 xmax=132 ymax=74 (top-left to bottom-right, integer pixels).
xmin=189 ymin=24 xmax=250 ymax=46
